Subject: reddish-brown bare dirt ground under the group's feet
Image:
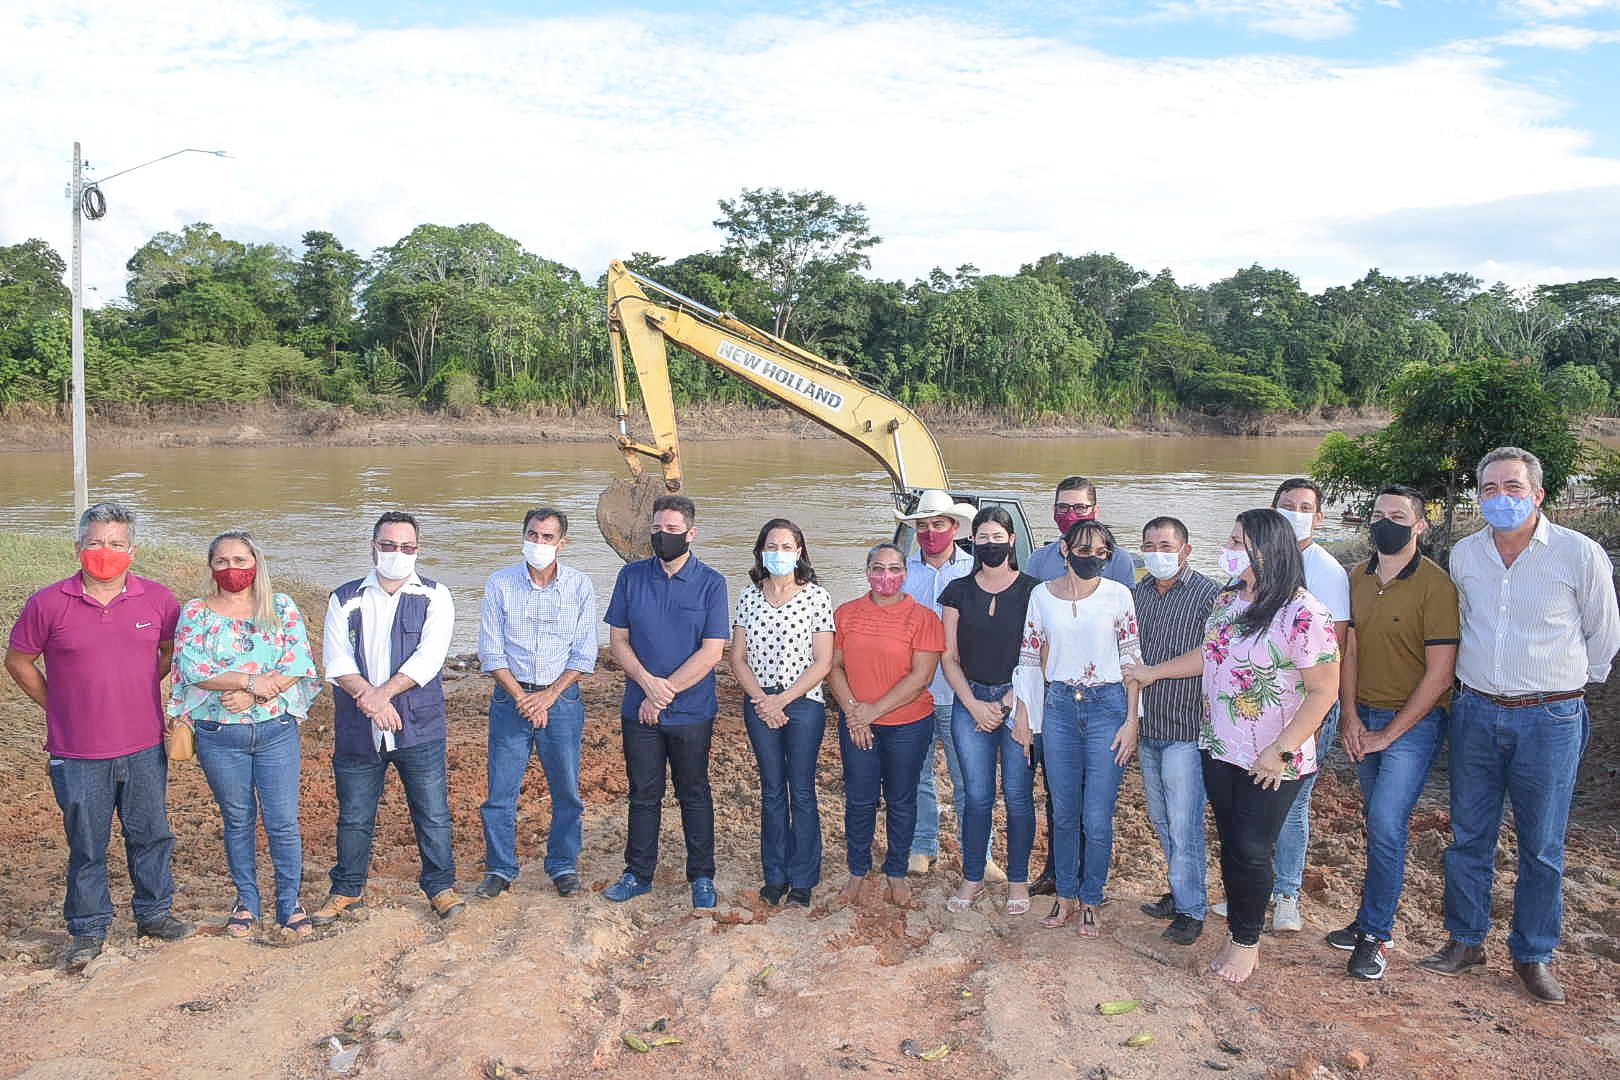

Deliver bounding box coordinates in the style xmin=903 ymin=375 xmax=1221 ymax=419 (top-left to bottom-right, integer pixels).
xmin=0 ymin=628 xmax=1620 ymax=1080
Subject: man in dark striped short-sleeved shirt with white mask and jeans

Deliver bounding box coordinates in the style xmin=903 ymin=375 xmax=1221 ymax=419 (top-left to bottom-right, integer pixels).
xmin=1136 ymin=518 xmax=1220 ymax=946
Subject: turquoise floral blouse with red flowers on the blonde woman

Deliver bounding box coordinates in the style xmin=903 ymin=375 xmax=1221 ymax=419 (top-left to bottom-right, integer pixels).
xmin=168 ymin=593 xmax=321 ymax=724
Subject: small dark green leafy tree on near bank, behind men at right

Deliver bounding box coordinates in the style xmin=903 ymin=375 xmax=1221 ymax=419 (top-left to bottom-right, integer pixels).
xmin=1309 ymin=358 xmax=1583 ymax=562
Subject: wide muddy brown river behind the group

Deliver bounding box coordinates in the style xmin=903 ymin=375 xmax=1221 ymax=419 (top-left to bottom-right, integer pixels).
xmin=0 ymin=436 xmax=1349 ymax=651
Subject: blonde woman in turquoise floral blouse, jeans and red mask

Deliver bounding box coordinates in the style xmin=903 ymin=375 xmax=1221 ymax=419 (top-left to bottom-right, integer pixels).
xmin=168 ymin=531 xmax=321 ymax=938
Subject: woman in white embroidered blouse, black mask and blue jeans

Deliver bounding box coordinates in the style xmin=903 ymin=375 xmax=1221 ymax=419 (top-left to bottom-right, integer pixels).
xmin=1025 ymin=520 xmax=1142 ymax=938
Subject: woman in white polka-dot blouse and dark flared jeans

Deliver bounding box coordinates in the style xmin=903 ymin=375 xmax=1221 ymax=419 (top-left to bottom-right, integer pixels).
xmin=731 ymin=518 xmax=833 ymax=907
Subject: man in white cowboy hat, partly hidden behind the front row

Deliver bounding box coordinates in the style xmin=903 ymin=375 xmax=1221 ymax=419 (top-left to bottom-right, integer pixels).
xmin=894 ymin=489 xmax=1006 ymax=881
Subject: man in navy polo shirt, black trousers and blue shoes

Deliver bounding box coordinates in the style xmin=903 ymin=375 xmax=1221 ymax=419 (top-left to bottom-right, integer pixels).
xmin=603 ymin=495 xmax=731 ymax=907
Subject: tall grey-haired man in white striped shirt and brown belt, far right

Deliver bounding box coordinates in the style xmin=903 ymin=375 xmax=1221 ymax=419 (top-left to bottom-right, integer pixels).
xmin=1421 ymin=447 xmax=1620 ymax=1004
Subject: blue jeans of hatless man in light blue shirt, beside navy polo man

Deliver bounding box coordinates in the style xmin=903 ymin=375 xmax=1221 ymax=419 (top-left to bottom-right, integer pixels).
xmin=478 ymin=683 xmax=585 ymax=881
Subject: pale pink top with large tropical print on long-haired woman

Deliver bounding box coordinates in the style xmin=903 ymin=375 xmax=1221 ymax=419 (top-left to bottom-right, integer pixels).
xmin=1199 ymin=589 xmax=1338 ymax=780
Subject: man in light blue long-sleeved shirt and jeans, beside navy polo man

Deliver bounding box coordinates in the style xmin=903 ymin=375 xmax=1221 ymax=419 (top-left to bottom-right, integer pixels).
xmin=475 ymin=507 xmax=596 ymax=900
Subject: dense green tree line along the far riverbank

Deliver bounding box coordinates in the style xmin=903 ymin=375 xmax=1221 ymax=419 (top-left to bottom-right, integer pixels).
xmin=0 ymin=189 xmax=1620 ymax=424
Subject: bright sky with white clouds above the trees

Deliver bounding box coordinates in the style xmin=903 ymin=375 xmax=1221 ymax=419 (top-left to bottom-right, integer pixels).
xmin=0 ymin=0 xmax=1620 ymax=304
